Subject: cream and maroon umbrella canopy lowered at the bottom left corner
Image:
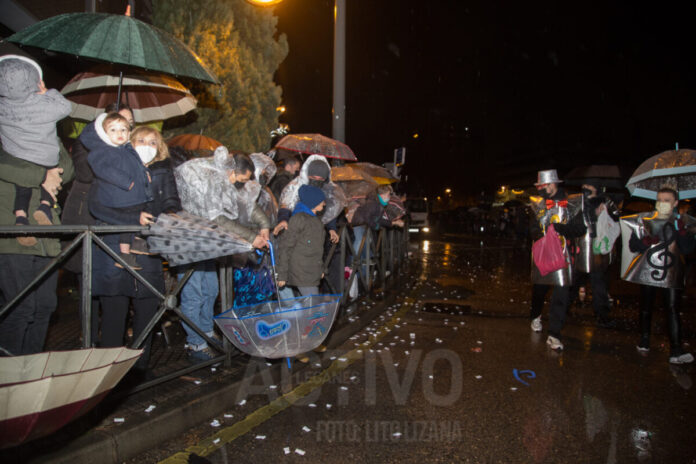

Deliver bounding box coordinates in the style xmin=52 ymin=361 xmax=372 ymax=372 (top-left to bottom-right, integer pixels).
xmin=0 ymin=347 xmax=142 ymax=448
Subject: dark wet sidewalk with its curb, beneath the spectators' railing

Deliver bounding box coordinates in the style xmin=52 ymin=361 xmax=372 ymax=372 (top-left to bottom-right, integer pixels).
xmin=0 ymin=270 xmax=403 ymax=464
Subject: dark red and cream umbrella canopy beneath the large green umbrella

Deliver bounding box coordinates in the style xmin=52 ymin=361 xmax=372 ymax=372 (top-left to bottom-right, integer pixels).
xmin=61 ymin=72 xmax=197 ymax=122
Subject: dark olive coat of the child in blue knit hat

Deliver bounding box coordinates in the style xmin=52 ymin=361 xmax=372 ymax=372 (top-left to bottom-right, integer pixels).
xmin=277 ymin=207 xmax=325 ymax=287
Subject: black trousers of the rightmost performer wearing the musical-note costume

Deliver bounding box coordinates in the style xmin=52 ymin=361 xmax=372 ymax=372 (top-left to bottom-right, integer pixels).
xmin=640 ymin=285 xmax=682 ymax=356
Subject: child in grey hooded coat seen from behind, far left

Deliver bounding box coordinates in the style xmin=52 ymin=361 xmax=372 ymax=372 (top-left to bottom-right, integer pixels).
xmin=0 ymin=55 xmax=72 ymax=246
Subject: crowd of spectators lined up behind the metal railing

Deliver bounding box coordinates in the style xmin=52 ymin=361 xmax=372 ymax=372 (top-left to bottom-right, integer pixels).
xmin=0 ymin=55 xmax=403 ymax=375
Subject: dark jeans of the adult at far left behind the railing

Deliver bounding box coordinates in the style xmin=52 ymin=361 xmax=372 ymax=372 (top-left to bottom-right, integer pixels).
xmin=0 ymin=254 xmax=58 ymax=355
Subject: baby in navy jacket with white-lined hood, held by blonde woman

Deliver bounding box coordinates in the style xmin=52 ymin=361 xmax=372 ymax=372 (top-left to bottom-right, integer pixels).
xmin=80 ymin=113 xmax=154 ymax=270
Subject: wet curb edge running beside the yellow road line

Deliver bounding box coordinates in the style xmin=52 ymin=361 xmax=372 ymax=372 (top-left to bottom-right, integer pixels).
xmin=39 ymin=279 xmax=400 ymax=464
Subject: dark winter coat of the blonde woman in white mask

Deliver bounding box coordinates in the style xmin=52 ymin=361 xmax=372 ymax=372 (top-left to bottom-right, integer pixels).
xmin=92 ymin=159 xmax=181 ymax=298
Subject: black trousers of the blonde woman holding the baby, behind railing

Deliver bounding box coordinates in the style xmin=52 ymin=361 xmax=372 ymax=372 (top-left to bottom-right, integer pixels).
xmin=99 ymin=296 xmax=159 ymax=369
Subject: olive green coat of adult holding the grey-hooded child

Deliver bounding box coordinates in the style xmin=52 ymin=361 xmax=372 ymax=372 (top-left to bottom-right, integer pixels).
xmin=0 ymin=145 xmax=75 ymax=256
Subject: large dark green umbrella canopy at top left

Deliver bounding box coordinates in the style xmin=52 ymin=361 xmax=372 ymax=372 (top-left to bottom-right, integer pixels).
xmin=7 ymin=13 xmax=218 ymax=84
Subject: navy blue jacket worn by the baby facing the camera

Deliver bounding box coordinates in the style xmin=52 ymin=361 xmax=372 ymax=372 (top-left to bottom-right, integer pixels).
xmin=80 ymin=118 xmax=152 ymax=209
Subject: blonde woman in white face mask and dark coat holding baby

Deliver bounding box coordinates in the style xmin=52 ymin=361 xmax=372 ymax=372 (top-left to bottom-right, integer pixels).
xmin=92 ymin=127 xmax=181 ymax=376
